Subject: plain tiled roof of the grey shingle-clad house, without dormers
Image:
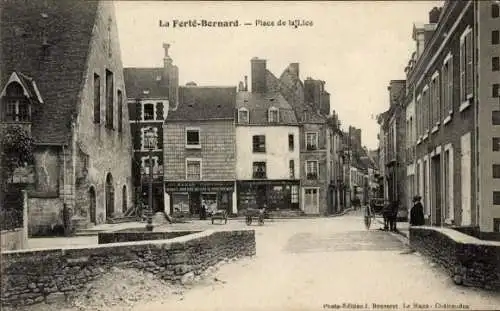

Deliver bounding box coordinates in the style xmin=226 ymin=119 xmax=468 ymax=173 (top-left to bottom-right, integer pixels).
xmin=167 ymin=86 xmax=236 ymax=121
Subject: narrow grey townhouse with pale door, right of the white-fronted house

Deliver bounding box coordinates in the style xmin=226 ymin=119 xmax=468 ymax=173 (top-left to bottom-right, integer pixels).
xmin=267 ymin=63 xmax=336 ymax=215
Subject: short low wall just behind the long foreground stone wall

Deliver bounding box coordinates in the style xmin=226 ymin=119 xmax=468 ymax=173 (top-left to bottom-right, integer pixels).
xmin=97 ymin=230 xmax=201 ymax=244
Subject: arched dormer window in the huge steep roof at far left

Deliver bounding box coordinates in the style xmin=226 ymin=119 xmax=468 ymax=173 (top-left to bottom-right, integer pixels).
xmin=3 ymin=82 xmax=30 ymax=122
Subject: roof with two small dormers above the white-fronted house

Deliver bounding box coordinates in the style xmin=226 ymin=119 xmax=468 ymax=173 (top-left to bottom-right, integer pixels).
xmin=236 ymin=92 xmax=297 ymax=125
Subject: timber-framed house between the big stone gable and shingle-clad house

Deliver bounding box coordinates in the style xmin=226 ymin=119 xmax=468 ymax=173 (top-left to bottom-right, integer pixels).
xmin=123 ymin=44 xmax=179 ymax=213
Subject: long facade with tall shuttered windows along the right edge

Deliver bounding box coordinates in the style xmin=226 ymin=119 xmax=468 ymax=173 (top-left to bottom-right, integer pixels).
xmin=386 ymin=1 xmax=500 ymax=238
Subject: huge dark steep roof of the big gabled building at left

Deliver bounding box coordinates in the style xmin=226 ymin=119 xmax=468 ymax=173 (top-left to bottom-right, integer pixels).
xmin=0 ymin=0 xmax=98 ymax=144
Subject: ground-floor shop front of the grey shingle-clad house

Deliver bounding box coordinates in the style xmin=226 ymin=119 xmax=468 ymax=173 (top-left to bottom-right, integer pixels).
xmin=165 ymin=181 xmax=236 ymax=216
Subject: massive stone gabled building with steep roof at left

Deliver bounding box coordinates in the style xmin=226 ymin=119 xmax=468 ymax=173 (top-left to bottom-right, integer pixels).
xmin=0 ymin=0 xmax=132 ymax=235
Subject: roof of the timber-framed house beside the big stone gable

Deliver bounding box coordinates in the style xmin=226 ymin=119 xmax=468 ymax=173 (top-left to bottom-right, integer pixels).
xmin=123 ymin=68 xmax=168 ymax=98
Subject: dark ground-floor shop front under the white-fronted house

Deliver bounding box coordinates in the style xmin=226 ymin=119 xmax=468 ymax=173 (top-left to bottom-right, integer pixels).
xmin=236 ymin=180 xmax=300 ymax=211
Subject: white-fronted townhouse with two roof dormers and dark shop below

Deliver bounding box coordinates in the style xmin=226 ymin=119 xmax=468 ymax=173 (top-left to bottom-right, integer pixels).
xmin=236 ymin=58 xmax=300 ymax=213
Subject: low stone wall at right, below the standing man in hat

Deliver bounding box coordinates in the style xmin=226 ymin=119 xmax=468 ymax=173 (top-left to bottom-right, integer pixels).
xmin=410 ymin=227 xmax=500 ymax=290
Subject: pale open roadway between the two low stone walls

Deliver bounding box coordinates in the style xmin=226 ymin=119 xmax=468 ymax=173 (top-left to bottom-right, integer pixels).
xmin=130 ymin=212 xmax=500 ymax=310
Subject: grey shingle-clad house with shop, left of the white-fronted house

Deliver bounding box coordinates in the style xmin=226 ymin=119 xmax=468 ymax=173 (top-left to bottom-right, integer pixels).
xmin=163 ymin=82 xmax=237 ymax=216
